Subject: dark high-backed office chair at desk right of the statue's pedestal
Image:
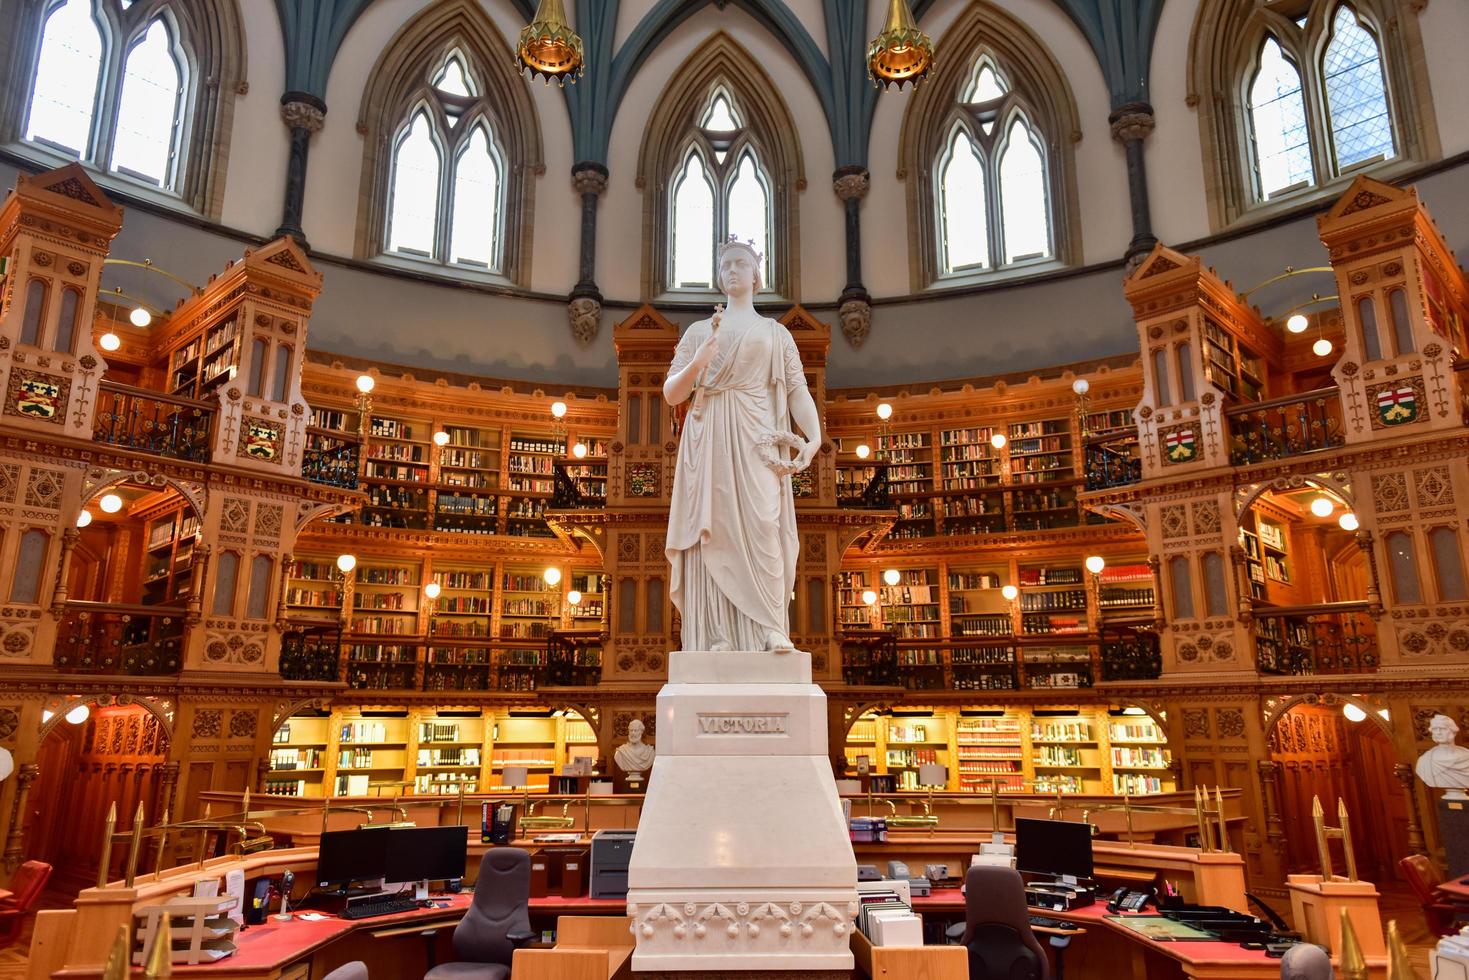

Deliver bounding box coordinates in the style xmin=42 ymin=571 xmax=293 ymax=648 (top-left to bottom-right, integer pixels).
xmin=959 ymin=864 xmax=1050 ymax=980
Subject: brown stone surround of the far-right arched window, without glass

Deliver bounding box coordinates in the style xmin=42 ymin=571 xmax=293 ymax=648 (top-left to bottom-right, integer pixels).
xmin=1185 ymin=0 xmax=1443 ymax=231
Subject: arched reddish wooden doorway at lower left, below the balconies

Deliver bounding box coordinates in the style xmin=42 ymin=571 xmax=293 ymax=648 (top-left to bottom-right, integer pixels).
xmin=25 ymin=702 xmax=169 ymax=890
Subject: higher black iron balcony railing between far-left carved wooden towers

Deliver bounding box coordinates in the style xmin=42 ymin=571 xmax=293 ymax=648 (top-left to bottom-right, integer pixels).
xmin=93 ymin=381 xmax=214 ymax=463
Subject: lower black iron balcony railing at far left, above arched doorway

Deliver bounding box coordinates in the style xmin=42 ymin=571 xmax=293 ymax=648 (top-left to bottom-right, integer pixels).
xmin=54 ymin=601 xmax=187 ymax=674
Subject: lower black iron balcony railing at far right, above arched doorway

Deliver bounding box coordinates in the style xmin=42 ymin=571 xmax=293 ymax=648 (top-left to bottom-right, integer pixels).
xmin=1253 ymin=602 xmax=1379 ymax=674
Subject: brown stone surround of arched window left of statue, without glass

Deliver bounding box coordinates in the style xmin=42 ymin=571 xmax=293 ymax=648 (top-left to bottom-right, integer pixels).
xmin=354 ymin=0 xmax=545 ymax=285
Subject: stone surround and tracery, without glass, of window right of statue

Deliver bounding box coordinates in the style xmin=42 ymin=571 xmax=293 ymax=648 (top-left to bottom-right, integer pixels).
xmin=896 ymin=0 xmax=1081 ymax=292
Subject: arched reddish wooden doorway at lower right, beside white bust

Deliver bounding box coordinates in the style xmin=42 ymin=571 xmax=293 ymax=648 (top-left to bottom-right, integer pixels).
xmin=1269 ymin=699 xmax=1409 ymax=883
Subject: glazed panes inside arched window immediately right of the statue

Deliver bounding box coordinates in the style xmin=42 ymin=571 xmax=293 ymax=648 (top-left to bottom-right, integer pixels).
xmin=933 ymin=51 xmax=1053 ymax=276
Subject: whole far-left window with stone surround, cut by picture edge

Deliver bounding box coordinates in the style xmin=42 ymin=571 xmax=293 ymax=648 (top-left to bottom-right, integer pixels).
xmin=0 ymin=0 xmax=244 ymax=217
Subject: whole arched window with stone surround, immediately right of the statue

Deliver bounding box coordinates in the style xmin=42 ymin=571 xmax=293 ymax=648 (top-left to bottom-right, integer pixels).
xmin=899 ymin=3 xmax=1081 ymax=291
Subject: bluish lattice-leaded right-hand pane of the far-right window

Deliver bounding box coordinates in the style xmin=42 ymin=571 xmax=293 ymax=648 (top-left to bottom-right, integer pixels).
xmin=1322 ymin=4 xmax=1393 ymax=170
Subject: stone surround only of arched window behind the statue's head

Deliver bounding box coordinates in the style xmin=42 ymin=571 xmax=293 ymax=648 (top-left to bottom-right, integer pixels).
xmin=638 ymin=31 xmax=806 ymax=303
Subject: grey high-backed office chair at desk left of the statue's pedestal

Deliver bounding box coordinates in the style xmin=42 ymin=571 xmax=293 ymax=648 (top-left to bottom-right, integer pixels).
xmin=423 ymin=848 xmax=535 ymax=980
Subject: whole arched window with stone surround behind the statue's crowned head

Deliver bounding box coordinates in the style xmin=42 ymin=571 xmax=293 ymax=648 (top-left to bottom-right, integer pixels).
xmin=638 ymin=32 xmax=804 ymax=300
